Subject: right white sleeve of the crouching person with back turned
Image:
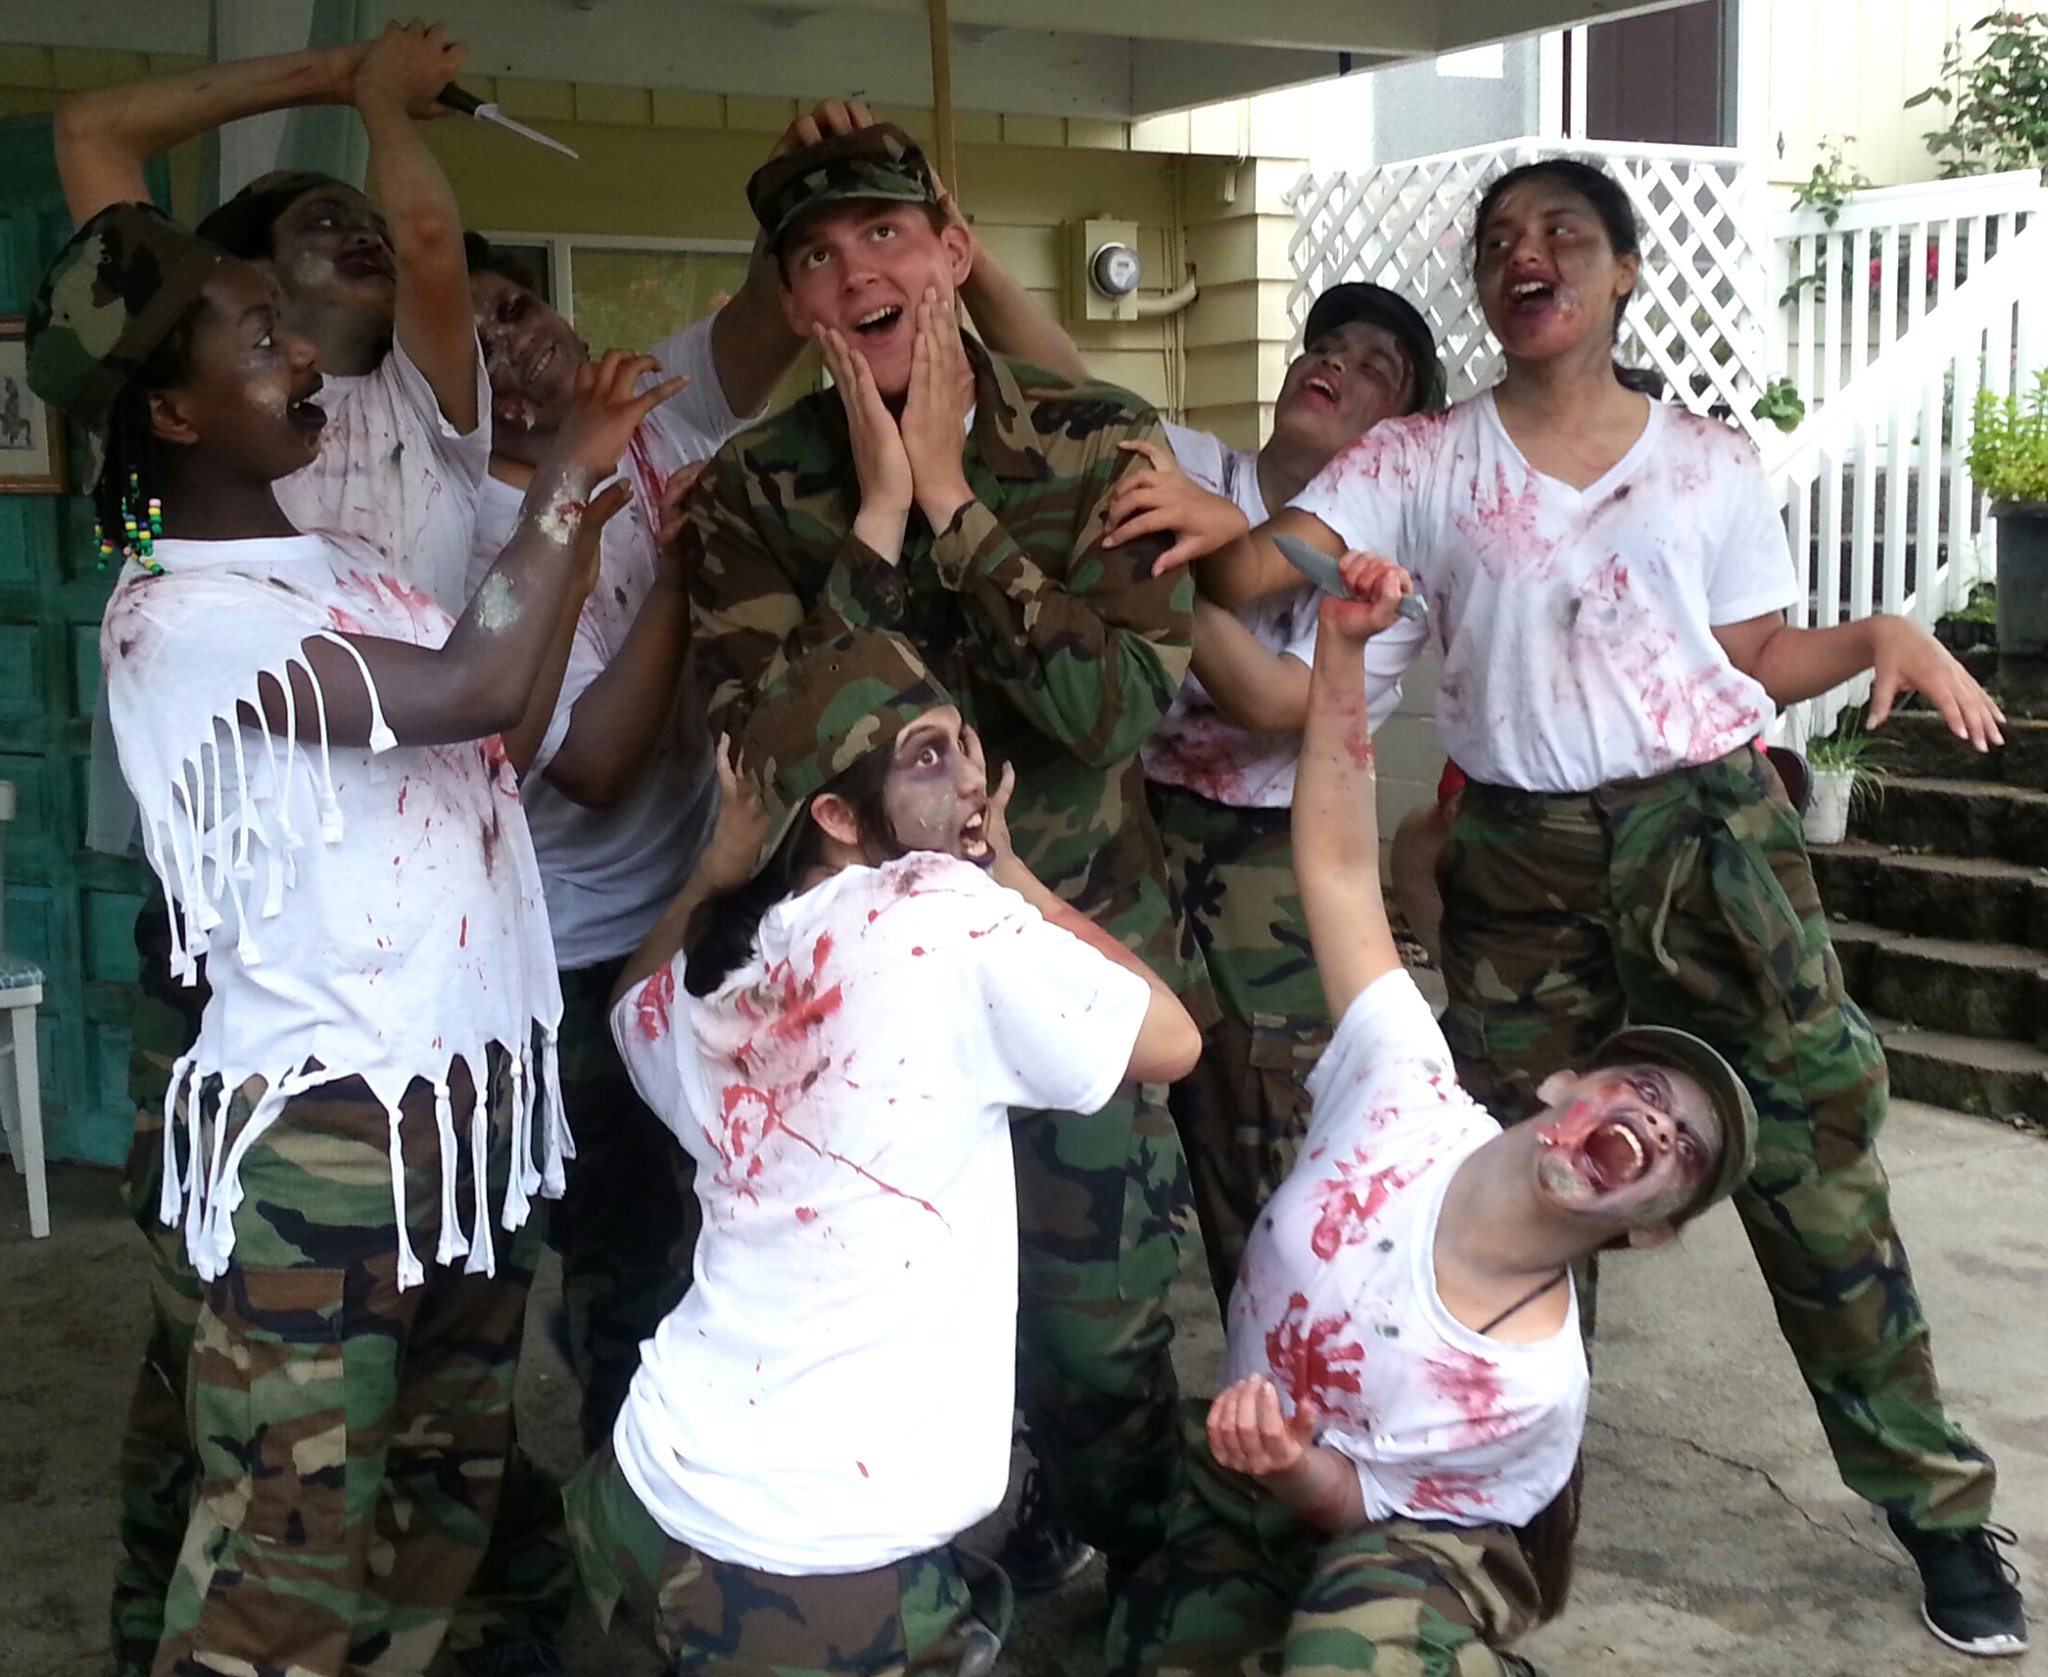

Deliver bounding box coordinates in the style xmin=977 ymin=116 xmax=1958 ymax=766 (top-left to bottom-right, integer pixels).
xmin=954 ymin=880 xmax=1151 ymax=1112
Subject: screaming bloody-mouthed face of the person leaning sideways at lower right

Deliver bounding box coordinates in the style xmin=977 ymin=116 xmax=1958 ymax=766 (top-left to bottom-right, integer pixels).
xmin=1536 ymin=1065 xmax=1720 ymax=1227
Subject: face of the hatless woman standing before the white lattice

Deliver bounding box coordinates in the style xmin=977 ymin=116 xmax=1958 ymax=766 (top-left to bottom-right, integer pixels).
xmin=1473 ymin=176 xmax=1640 ymax=360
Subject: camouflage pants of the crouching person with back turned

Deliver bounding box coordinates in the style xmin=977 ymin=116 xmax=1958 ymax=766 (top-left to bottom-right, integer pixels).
xmin=563 ymin=1444 xmax=1008 ymax=1677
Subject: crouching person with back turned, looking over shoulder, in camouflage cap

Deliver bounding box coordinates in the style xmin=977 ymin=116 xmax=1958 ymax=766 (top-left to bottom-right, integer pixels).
xmin=563 ymin=631 xmax=1200 ymax=1677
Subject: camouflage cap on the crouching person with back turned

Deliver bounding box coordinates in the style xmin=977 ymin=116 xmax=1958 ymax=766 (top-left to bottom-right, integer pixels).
xmin=739 ymin=629 xmax=952 ymax=868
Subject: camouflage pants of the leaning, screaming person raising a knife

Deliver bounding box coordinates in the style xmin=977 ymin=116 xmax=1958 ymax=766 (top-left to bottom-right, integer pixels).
xmin=1108 ymin=1403 xmax=1536 ymax=1677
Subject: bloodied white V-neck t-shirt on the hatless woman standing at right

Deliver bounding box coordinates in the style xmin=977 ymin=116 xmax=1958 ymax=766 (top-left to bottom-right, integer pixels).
xmin=1292 ymin=391 xmax=1798 ymax=792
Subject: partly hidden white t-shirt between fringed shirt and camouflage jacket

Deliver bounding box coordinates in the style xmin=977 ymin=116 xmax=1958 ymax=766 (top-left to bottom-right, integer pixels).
xmin=469 ymin=319 xmax=745 ymax=971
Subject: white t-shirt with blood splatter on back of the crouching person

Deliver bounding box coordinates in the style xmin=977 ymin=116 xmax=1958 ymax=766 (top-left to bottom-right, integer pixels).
xmin=612 ymin=852 xmax=1149 ymax=1575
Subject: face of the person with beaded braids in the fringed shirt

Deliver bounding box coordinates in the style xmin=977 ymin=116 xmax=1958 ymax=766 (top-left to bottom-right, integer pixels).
xmin=154 ymin=262 xmax=328 ymax=483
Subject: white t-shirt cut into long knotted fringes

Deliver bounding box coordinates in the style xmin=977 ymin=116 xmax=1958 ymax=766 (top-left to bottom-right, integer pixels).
xmin=100 ymin=536 xmax=567 ymax=1286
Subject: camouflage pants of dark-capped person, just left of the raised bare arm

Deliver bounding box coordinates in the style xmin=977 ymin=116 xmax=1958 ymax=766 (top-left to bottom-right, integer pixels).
xmin=1147 ymin=786 xmax=1329 ymax=1308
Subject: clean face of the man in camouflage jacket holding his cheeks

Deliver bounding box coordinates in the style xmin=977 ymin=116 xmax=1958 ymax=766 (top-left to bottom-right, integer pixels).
xmin=780 ymin=199 xmax=969 ymax=401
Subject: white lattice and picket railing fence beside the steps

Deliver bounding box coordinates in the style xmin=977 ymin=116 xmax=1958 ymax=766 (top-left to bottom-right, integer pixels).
xmin=1288 ymin=139 xmax=2048 ymax=739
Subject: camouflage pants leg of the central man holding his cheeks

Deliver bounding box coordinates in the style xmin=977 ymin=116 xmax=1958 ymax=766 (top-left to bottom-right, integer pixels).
xmin=1010 ymin=1083 xmax=1188 ymax=1579
